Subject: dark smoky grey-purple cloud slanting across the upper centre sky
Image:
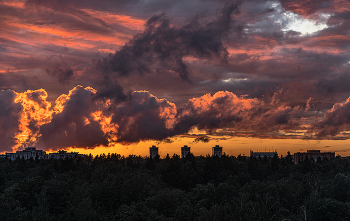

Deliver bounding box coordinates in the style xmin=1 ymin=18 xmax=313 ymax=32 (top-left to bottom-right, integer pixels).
xmin=97 ymin=2 xmax=243 ymax=80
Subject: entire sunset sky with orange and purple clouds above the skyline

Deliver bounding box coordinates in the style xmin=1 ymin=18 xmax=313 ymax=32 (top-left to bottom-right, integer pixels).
xmin=0 ymin=0 xmax=350 ymax=156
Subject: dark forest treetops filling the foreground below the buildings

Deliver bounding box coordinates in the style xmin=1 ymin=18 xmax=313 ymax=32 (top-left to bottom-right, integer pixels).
xmin=0 ymin=154 xmax=350 ymax=221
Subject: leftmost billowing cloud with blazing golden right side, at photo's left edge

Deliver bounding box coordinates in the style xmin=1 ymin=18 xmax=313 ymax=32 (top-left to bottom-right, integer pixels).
xmin=0 ymin=89 xmax=52 ymax=152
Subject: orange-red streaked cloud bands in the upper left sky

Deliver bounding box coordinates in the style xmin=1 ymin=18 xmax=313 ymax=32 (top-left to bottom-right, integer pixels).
xmin=0 ymin=1 xmax=145 ymax=60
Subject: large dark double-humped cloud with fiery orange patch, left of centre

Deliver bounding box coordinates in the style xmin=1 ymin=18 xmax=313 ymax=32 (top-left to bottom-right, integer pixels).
xmin=38 ymin=86 xmax=176 ymax=149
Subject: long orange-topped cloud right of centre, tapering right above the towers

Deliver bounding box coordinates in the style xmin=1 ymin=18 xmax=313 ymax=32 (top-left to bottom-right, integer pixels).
xmin=174 ymin=91 xmax=306 ymax=134
